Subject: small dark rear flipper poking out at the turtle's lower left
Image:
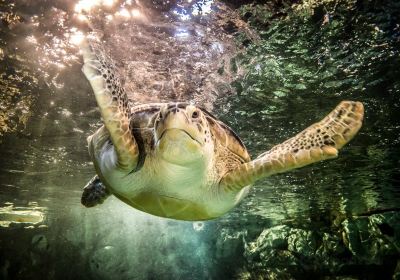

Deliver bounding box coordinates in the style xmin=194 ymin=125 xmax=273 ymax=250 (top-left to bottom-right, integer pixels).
xmin=81 ymin=175 xmax=110 ymax=207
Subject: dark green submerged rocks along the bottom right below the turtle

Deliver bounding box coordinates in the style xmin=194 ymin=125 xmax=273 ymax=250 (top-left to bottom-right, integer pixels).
xmin=217 ymin=212 xmax=400 ymax=279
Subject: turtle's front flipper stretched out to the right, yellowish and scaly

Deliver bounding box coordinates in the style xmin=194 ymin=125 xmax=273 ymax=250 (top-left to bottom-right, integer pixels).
xmin=220 ymin=101 xmax=364 ymax=192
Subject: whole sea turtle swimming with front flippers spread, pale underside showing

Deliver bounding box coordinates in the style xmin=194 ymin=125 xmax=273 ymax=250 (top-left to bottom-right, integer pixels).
xmin=81 ymin=38 xmax=364 ymax=221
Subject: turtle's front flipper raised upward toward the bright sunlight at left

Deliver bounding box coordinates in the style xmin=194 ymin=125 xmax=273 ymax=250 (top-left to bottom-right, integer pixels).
xmin=81 ymin=38 xmax=139 ymax=172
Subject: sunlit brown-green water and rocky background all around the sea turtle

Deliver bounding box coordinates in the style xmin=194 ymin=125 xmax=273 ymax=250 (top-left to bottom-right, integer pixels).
xmin=0 ymin=0 xmax=400 ymax=279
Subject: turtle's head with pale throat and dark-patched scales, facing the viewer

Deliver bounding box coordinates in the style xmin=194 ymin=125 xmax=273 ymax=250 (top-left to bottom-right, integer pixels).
xmin=155 ymin=103 xmax=214 ymax=165
